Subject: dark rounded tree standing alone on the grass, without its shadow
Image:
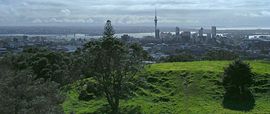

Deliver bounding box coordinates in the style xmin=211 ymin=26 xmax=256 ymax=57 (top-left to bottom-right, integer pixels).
xmin=223 ymin=60 xmax=253 ymax=94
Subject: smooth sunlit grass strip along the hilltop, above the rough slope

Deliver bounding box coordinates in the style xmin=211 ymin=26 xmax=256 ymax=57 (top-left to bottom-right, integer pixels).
xmin=147 ymin=61 xmax=270 ymax=74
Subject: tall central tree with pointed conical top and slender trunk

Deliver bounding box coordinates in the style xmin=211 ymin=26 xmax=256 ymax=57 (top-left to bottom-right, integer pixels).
xmin=83 ymin=20 xmax=145 ymax=114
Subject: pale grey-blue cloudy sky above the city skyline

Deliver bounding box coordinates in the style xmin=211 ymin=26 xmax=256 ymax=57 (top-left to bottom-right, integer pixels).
xmin=0 ymin=0 xmax=270 ymax=27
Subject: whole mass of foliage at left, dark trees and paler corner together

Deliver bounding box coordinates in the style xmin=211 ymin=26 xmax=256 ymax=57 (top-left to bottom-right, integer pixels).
xmin=0 ymin=47 xmax=85 ymax=114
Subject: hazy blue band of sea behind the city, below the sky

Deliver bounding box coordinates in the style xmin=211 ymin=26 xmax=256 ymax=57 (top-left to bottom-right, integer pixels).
xmin=0 ymin=26 xmax=270 ymax=39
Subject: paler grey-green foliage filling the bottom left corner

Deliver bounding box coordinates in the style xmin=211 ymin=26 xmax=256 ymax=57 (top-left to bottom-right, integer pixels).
xmin=0 ymin=65 xmax=64 ymax=114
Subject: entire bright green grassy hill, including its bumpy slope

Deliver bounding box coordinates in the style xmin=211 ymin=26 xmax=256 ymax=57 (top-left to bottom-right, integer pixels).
xmin=63 ymin=61 xmax=270 ymax=114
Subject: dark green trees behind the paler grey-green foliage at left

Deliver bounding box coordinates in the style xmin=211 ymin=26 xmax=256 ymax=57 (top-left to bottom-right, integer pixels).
xmin=3 ymin=47 xmax=82 ymax=86
